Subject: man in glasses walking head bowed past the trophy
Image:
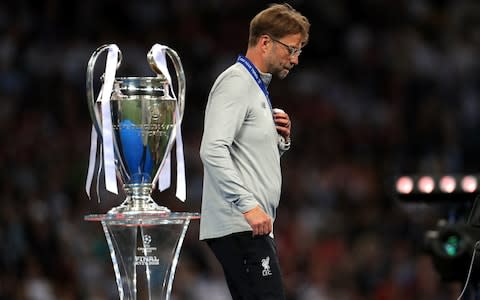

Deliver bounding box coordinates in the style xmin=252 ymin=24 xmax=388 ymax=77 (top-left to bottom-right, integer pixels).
xmin=200 ymin=4 xmax=310 ymax=300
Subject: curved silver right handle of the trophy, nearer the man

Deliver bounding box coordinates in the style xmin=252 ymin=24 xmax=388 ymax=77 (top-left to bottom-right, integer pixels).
xmin=147 ymin=46 xmax=186 ymax=125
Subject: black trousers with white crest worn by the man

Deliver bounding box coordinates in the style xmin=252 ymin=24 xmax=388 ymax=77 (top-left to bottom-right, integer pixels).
xmin=206 ymin=231 xmax=285 ymax=300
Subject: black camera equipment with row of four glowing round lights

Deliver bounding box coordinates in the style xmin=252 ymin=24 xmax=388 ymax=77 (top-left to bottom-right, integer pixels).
xmin=395 ymin=175 xmax=480 ymax=287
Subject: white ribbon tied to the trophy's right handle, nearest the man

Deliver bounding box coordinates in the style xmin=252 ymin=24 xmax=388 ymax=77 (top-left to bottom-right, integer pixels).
xmin=151 ymin=44 xmax=187 ymax=202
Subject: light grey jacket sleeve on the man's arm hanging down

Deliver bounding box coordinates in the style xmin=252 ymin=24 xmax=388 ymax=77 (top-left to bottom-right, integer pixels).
xmin=200 ymin=74 xmax=258 ymax=213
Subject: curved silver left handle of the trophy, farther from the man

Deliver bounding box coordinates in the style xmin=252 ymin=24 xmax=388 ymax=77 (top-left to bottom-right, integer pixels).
xmin=87 ymin=44 xmax=122 ymax=139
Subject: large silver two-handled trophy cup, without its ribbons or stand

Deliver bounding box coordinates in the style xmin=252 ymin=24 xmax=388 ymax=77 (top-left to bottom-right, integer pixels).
xmin=87 ymin=45 xmax=185 ymax=214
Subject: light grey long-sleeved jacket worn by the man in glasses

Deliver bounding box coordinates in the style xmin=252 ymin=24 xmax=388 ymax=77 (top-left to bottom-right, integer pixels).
xmin=200 ymin=63 xmax=288 ymax=240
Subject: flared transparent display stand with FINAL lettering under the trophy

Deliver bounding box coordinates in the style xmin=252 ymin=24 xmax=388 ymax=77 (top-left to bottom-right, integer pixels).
xmin=85 ymin=213 xmax=200 ymax=300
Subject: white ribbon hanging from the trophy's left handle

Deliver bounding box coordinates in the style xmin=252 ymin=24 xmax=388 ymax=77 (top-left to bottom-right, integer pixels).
xmin=85 ymin=44 xmax=120 ymax=197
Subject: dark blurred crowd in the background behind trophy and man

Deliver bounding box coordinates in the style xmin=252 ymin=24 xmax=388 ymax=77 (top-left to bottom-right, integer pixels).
xmin=0 ymin=0 xmax=480 ymax=300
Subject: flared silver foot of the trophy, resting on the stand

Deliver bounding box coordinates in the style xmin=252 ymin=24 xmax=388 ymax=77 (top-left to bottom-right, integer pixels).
xmin=107 ymin=197 xmax=171 ymax=216
